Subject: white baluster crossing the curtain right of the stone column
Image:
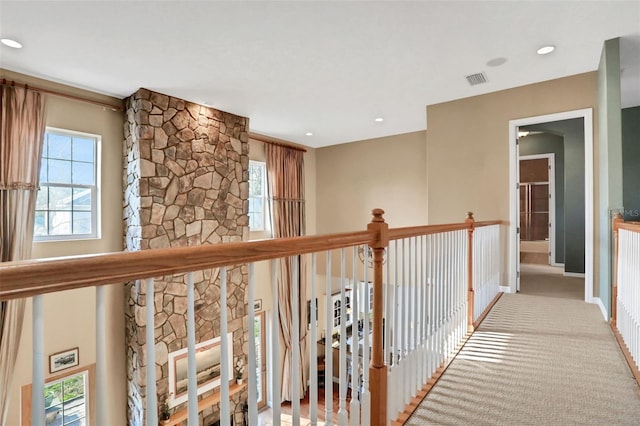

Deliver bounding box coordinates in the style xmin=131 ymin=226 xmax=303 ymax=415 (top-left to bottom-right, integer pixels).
xmin=289 ymin=256 xmax=301 ymax=426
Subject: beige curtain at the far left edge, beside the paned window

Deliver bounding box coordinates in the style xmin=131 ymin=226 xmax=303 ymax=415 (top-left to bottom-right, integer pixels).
xmin=0 ymin=85 xmax=45 ymax=424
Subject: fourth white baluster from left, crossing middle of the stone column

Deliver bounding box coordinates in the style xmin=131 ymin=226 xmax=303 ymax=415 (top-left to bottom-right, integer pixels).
xmin=186 ymin=272 xmax=198 ymax=426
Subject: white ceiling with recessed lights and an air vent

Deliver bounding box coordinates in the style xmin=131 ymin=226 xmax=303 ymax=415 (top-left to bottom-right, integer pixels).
xmin=0 ymin=0 xmax=640 ymax=147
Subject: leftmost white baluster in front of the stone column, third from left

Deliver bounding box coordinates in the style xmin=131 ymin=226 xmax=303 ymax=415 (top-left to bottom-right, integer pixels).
xmin=145 ymin=278 xmax=158 ymax=426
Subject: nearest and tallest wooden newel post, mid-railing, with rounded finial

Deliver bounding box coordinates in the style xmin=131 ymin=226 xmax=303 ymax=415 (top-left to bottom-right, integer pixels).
xmin=367 ymin=209 xmax=389 ymax=426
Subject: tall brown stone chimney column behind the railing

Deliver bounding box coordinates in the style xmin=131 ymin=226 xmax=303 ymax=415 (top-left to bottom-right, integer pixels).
xmin=123 ymin=89 xmax=249 ymax=425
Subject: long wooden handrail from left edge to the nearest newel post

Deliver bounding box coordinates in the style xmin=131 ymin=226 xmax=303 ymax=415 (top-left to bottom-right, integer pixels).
xmin=0 ymin=231 xmax=376 ymax=301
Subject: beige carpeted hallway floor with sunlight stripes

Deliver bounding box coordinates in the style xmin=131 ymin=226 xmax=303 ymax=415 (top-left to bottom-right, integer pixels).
xmin=406 ymin=268 xmax=640 ymax=425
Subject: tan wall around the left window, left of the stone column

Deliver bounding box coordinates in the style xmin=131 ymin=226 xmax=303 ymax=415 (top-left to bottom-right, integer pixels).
xmin=0 ymin=70 xmax=126 ymax=425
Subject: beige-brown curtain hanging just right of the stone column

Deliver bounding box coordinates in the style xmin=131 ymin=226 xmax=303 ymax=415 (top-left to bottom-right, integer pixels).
xmin=265 ymin=144 xmax=307 ymax=401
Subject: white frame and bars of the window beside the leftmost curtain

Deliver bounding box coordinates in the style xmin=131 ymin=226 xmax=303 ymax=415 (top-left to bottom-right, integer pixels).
xmin=33 ymin=127 xmax=102 ymax=242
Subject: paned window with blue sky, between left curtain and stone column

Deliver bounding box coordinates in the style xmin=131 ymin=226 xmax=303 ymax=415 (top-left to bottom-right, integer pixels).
xmin=34 ymin=128 xmax=100 ymax=241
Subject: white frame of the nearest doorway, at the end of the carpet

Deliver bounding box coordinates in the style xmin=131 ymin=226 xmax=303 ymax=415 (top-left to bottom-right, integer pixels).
xmin=508 ymin=108 xmax=596 ymax=303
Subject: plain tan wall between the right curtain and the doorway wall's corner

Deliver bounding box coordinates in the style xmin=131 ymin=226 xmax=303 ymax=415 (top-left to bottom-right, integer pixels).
xmin=317 ymin=131 xmax=427 ymax=234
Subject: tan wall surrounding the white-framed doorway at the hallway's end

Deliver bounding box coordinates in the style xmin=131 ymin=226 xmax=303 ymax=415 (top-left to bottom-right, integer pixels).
xmin=426 ymin=72 xmax=598 ymax=294
